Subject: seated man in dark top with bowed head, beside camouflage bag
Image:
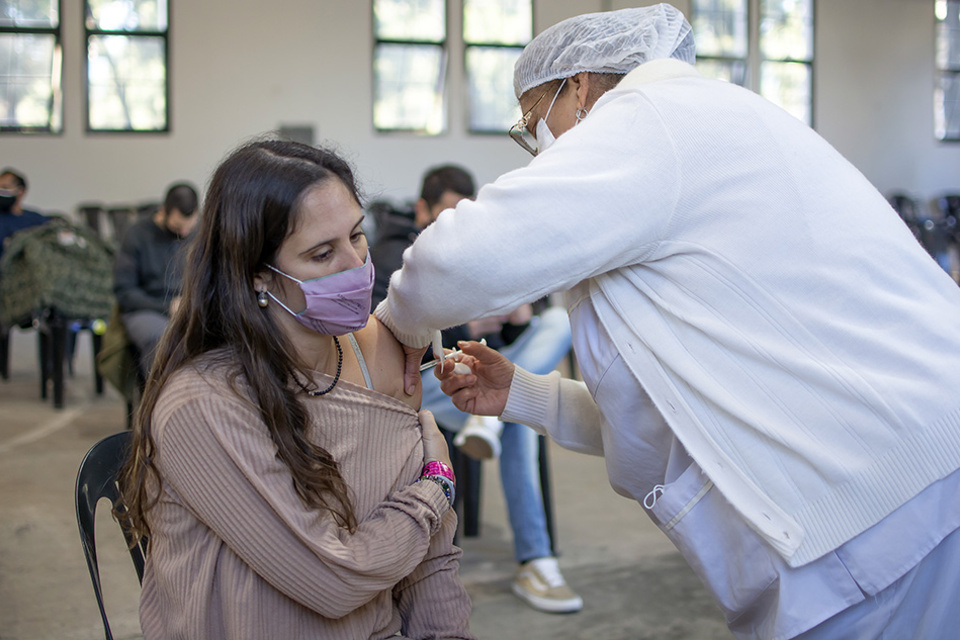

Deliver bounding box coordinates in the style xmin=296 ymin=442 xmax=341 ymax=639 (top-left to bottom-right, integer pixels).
xmin=113 ymin=182 xmax=198 ymax=379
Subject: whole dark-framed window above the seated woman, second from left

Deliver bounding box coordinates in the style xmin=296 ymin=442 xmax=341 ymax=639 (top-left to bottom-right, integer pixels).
xmin=85 ymin=0 xmax=170 ymax=132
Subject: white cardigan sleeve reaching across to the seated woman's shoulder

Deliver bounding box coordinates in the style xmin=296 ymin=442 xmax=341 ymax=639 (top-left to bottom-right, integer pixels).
xmin=375 ymin=92 xmax=680 ymax=347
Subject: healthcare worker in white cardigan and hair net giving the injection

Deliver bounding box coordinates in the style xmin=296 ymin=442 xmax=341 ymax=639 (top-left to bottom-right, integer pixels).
xmin=376 ymin=5 xmax=960 ymax=640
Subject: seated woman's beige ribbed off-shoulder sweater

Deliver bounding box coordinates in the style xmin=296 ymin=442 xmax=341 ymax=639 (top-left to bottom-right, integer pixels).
xmin=140 ymin=354 xmax=473 ymax=640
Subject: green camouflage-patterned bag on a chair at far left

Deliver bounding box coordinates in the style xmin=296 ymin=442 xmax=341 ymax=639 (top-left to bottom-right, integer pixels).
xmin=0 ymin=218 xmax=114 ymax=327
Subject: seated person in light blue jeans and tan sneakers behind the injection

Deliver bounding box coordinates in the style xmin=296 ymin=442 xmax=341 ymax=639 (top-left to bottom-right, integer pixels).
xmin=370 ymin=165 xmax=583 ymax=613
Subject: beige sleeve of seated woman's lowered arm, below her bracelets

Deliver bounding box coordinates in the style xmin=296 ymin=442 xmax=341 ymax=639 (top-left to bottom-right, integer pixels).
xmin=394 ymin=508 xmax=474 ymax=640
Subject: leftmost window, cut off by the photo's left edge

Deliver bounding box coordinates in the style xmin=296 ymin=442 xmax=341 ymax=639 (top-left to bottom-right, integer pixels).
xmin=0 ymin=0 xmax=63 ymax=133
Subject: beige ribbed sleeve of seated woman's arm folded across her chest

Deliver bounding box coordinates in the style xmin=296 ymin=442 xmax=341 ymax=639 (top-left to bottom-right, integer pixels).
xmin=156 ymin=394 xmax=449 ymax=618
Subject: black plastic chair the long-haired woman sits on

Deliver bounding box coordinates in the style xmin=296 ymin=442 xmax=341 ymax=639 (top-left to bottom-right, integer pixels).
xmin=77 ymin=431 xmax=146 ymax=640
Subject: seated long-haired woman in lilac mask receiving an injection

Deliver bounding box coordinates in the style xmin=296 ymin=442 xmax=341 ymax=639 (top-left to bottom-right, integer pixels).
xmin=121 ymin=141 xmax=473 ymax=640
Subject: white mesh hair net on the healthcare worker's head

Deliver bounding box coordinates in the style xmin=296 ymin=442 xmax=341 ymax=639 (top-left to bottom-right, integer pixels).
xmin=513 ymin=4 xmax=694 ymax=99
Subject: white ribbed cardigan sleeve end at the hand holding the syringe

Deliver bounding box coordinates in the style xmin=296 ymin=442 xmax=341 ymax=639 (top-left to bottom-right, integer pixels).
xmin=500 ymin=367 xmax=603 ymax=456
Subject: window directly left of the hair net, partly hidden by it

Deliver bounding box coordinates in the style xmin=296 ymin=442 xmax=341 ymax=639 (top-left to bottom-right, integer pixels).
xmin=463 ymin=0 xmax=533 ymax=133
